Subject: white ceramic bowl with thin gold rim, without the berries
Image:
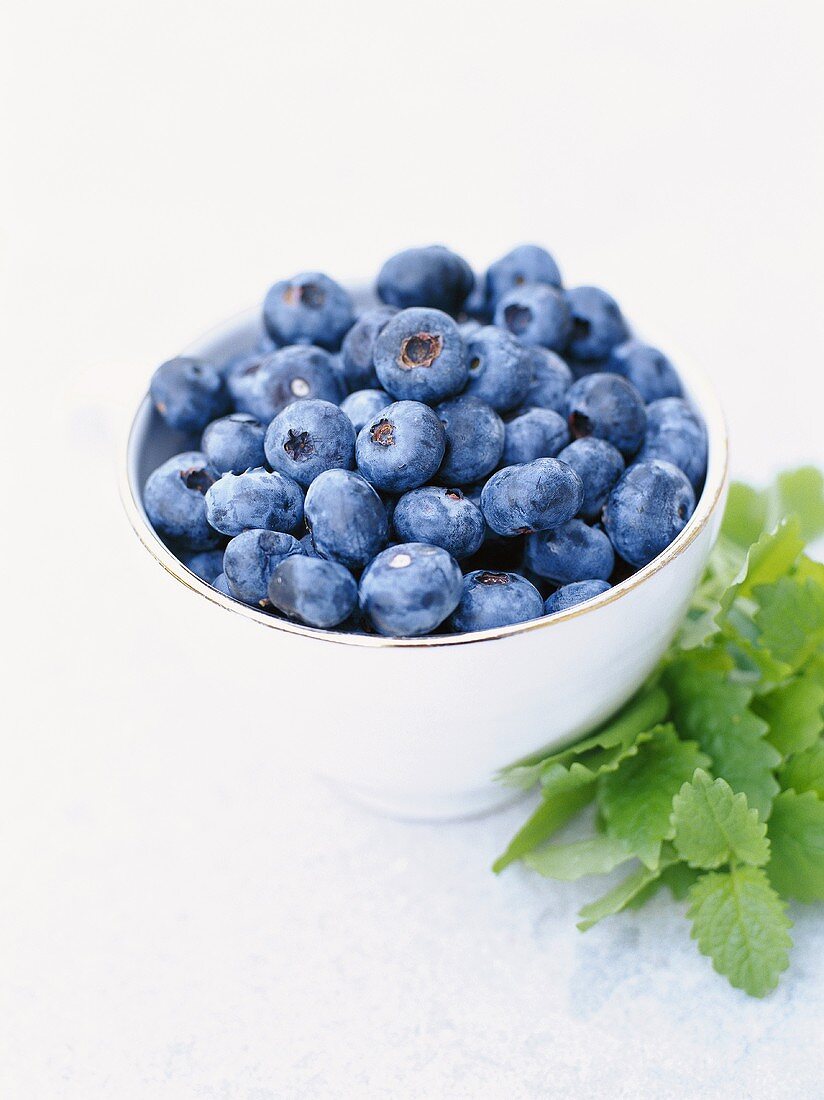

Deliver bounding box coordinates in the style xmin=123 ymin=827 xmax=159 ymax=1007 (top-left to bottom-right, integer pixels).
xmin=123 ymin=299 xmax=727 ymax=820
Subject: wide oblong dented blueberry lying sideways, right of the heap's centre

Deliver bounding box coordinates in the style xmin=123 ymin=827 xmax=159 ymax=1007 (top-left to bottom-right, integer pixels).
xmin=481 ymin=459 xmax=584 ymax=535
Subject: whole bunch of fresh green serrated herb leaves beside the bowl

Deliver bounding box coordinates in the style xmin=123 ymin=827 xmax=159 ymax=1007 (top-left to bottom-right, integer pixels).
xmin=494 ymin=468 xmax=824 ymax=997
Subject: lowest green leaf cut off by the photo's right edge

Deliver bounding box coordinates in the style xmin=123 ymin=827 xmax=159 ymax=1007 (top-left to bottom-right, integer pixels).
xmin=767 ymin=791 xmax=824 ymax=902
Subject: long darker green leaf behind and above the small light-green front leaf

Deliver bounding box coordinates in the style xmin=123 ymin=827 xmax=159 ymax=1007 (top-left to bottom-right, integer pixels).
xmin=663 ymin=651 xmax=781 ymax=821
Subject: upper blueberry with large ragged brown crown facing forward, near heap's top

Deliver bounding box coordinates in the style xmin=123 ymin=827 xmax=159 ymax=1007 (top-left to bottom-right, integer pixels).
xmin=375 ymin=309 xmax=466 ymax=405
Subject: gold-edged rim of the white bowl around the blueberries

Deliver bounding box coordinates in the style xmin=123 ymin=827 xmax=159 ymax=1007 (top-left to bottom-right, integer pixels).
xmin=120 ymin=307 xmax=729 ymax=649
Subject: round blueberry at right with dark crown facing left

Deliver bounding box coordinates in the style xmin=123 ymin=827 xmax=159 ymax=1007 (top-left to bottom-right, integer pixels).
xmin=567 ymin=373 xmax=647 ymax=458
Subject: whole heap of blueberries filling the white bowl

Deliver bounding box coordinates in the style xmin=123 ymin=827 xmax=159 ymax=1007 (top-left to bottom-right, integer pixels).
xmin=144 ymin=244 xmax=707 ymax=636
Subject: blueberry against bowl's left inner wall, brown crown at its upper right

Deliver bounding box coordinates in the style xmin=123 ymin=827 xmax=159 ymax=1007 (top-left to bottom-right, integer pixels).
xmin=143 ymin=451 xmax=218 ymax=550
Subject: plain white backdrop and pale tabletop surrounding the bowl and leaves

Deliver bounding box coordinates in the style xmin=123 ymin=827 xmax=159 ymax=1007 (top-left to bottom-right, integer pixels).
xmin=0 ymin=0 xmax=824 ymax=1100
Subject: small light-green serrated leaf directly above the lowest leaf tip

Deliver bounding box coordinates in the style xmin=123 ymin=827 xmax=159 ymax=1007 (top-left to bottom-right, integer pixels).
xmin=672 ymin=769 xmax=770 ymax=870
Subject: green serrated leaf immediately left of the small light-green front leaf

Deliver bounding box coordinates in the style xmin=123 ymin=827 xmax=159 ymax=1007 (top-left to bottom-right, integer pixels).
xmin=597 ymin=725 xmax=708 ymax=868
